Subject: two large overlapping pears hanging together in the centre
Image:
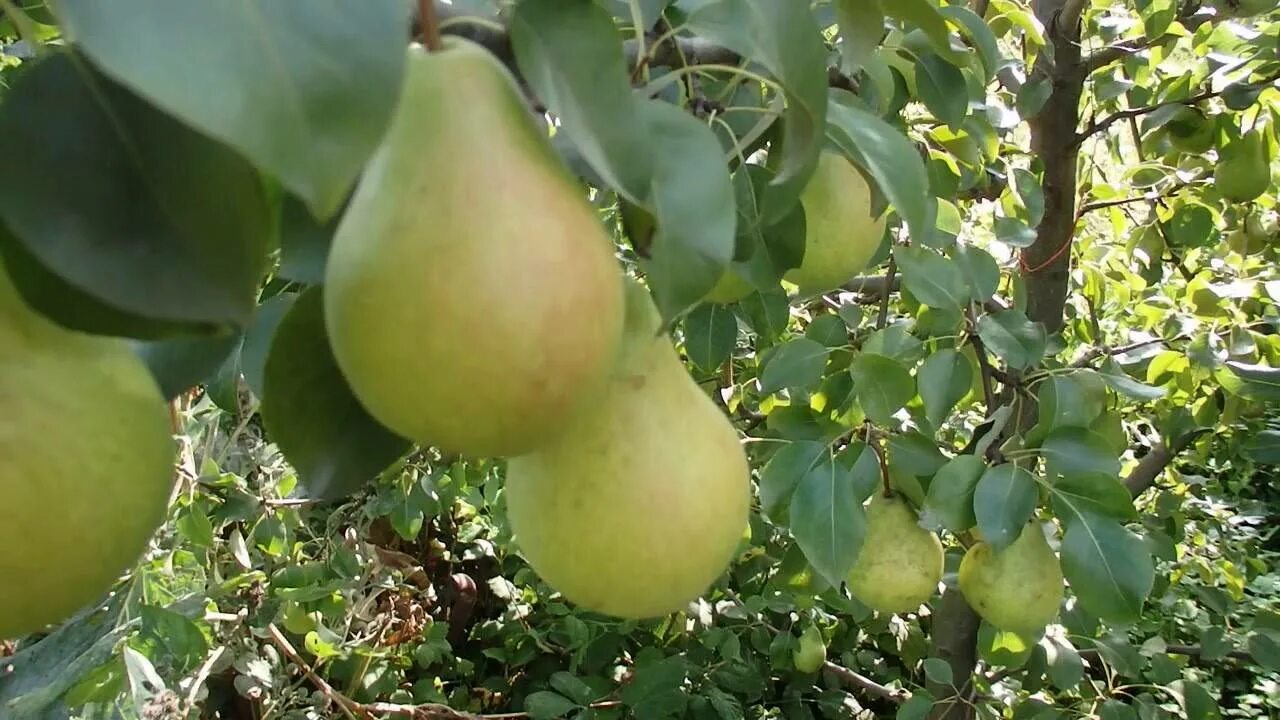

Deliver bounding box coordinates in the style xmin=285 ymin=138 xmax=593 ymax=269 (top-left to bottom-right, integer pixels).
xmin=324 ymin=38 xmax=750 ymax=618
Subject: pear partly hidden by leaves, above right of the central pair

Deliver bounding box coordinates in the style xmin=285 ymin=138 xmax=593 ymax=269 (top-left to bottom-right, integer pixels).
xmin=783 ymin=150 xmax=884 ymax=293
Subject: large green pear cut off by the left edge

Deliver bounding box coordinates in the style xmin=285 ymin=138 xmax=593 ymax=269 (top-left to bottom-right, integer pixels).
xmin=0 ymin=266 xmax=174 ymax=632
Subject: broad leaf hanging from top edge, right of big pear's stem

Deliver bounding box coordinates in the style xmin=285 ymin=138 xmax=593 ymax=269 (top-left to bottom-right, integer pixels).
xmin=511 ymin=0 xmax=650 ymax=203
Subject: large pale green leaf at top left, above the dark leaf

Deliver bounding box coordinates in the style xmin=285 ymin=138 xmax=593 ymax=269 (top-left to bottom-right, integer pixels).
xmin=58 ymin=0 xmax=410 ymax=218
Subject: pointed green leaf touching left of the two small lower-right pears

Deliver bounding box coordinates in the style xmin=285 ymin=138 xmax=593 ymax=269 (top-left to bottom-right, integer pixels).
xmin=790 ymin=456 xmax=867 ymax=585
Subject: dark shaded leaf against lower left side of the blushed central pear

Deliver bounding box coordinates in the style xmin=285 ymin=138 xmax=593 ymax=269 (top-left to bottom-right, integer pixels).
xmin=262 ymin=287 xmax=410 ymax=498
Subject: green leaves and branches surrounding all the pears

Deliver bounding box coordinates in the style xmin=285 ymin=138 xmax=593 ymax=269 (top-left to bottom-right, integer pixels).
xmin=0 ymin=0 xmax=1280 ymax=720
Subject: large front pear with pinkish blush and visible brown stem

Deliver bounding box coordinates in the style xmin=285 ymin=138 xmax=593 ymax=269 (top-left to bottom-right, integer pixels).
xmin=324 ymin=38 xmax=622 ymax=456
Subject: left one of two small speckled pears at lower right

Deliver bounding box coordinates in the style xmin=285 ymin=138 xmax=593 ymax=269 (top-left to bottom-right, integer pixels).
xmin=847 ymin=495 xmax=943 ymax=612
